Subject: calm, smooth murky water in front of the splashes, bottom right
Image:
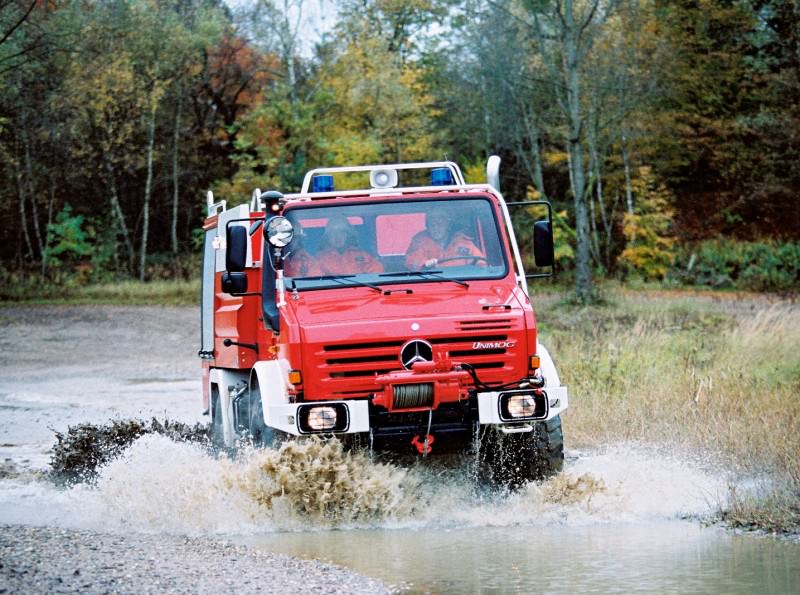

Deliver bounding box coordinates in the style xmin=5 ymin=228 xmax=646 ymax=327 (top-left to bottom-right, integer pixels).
xmin=242 ymin=521 xmax=800 ymax=593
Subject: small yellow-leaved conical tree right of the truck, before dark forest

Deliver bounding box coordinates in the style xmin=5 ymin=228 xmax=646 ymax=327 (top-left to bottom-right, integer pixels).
xmin=619 ymin=167 xmax=675 ymax=279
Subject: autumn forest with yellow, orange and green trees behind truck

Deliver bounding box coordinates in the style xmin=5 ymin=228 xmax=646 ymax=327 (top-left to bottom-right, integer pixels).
xmin=0 ymin=0 xmax=800 ymax=302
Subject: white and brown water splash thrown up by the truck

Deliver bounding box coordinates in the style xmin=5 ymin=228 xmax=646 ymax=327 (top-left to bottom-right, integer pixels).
xmin=0 ymin=434 xmax=726 ymax=535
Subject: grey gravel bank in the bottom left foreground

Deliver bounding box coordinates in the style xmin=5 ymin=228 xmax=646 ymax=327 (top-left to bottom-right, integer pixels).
xmin=0 ymin=526 xmax=389 ymax=594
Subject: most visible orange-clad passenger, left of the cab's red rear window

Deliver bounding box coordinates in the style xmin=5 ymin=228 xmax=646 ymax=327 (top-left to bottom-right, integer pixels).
xmin=317 ymin=215 xmax=383 ymax=275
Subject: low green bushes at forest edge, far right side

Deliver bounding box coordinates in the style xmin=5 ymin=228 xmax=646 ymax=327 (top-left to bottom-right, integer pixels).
xmin=671 ymin=239 xmax=800 ymax=291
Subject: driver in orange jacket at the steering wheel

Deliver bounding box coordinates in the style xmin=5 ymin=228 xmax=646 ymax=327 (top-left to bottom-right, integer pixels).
xmin=406 ymin=208 xmax=485 ymax=269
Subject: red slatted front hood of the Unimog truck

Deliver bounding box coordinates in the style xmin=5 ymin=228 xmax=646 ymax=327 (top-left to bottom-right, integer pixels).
xmin=286 ymin=281 xmax=535 ymax=399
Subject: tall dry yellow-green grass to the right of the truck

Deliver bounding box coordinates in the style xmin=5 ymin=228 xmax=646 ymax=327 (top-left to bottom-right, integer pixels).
xmin=538 ymin=290 xmax=800 ymax=532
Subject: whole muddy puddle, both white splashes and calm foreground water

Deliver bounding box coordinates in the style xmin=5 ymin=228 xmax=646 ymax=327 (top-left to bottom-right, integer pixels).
xmin=0 ymin=434 xmax=800 ymax=592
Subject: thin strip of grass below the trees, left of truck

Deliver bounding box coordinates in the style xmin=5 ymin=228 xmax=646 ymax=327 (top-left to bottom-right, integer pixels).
xmin=0 ymin=279 xmax=200 ymax=306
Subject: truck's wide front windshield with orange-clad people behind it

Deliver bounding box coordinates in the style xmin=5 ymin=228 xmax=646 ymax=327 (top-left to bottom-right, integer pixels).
xmin=284 ymin=197 xmax=508 ymax=290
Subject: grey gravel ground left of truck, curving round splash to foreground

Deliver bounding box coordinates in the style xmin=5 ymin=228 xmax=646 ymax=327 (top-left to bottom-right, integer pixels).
xmin=0 ymin=306 xmax=390 ymax=593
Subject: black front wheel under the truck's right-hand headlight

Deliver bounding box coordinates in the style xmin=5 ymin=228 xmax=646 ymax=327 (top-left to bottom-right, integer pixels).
xmin=478 ymin=416 xmax=564 ymax=488
